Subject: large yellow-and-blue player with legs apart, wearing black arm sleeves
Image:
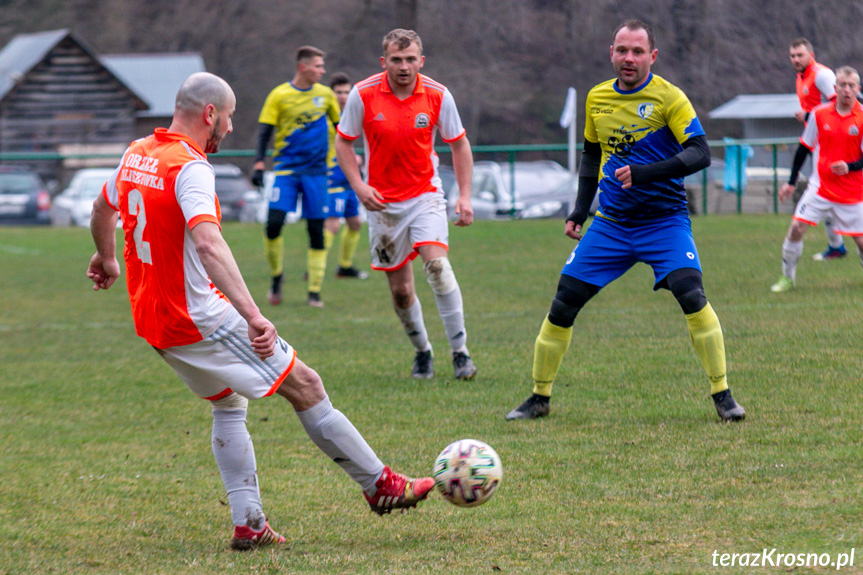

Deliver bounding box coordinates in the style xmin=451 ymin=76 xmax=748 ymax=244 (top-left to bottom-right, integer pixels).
xmin=506 ymin=20 xmax=746 ymax=421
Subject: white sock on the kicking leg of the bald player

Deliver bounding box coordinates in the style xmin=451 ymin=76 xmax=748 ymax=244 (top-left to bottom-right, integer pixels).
xmin=297 ymin=397 xmax=384 ymax=495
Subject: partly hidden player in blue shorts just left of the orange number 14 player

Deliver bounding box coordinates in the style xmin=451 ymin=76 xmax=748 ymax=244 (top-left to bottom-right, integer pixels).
xmin=324 ymin=72 xmax=369 ymax=280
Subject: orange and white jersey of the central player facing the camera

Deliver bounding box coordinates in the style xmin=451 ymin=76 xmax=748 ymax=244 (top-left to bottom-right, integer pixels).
xmin=337 ymin=72 xmax=465 ymax=202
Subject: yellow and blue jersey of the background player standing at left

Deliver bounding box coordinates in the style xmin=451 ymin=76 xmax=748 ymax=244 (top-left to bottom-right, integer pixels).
xmin=258 ymin=82 xmax=339 ymax=176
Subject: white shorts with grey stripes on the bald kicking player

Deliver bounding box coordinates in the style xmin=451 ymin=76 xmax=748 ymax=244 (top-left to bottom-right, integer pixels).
xmin=156 ymin=308 xmax=297 ymax=401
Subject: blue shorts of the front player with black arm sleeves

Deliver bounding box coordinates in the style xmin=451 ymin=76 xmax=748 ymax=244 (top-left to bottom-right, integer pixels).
xmin=561 ymin=215 xmax=701 ymax=290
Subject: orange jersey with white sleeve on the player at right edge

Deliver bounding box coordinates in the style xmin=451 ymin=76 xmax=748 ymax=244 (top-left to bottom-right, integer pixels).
xmin=800 ymin=101 xmax=863 ymax=204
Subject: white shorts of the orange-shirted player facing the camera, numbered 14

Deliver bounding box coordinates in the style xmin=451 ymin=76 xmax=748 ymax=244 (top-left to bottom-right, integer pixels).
xmin=369 ymin=192 xmax=449 ymax=272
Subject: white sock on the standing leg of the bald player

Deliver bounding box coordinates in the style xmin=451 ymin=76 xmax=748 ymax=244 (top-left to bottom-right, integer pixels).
xmin=212 ymin=409 xmax=266 ymax=531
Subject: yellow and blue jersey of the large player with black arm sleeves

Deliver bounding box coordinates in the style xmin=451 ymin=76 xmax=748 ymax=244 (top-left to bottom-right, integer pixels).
xmin=584 ymin=73 xmax=704 ymax=225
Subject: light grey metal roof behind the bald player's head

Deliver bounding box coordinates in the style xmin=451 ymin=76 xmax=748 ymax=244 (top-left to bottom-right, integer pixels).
xmin=100 ymin=53 xmax=206 ymax=117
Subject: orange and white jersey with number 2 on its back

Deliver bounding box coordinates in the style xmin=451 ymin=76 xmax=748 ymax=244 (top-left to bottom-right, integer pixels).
xmin=102 ymin=128 xmax=230 ymax=349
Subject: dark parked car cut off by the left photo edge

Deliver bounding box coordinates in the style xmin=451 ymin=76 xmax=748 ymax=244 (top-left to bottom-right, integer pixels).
xmin=0 ymin=166 xmax=51 ymax=224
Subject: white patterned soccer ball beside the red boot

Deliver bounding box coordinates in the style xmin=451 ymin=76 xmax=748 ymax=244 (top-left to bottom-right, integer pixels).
xmin=432 ymin=439 xmax=503 ymax=507
